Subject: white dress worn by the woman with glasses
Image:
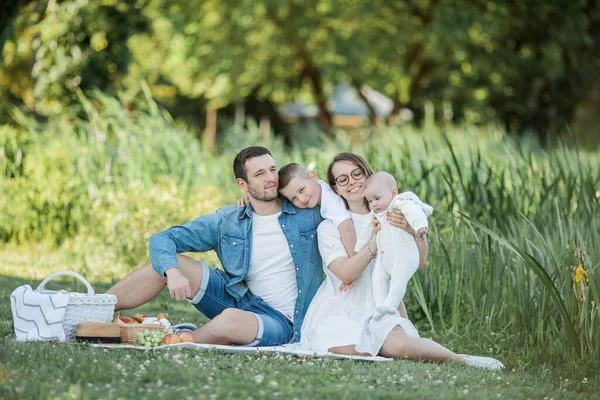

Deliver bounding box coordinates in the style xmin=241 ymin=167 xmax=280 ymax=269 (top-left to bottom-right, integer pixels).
xmin=300 ymin=213 xmax=419 ymax=355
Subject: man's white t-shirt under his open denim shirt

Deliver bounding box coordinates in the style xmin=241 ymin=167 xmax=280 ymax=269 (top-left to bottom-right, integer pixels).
xmin=246 ymin=212 xmax=298 ymax=321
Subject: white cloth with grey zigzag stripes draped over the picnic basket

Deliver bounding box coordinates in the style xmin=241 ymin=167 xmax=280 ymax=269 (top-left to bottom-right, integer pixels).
xmin=10 ymin=285 xmax=69 ymax=342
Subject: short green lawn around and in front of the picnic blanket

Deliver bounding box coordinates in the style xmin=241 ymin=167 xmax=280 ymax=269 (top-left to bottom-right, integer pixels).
xmin=0 ymin=249 xmax=600 ymax=399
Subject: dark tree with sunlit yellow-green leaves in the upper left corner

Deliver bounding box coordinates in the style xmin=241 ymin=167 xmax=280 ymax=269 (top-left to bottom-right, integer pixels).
xmin=0 ymin=0 xmax=147 ymax=116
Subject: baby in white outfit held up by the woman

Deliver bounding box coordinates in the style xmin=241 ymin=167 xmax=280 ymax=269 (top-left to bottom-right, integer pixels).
xmin=356 ymin=172 xmax=433 ymax=320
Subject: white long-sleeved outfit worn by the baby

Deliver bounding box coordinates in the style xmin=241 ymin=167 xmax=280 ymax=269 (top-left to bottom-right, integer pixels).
xmin=356 ymin=192 xmax=433 ymax=320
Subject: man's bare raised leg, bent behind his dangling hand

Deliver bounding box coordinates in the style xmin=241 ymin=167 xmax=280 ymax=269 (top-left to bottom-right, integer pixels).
xmin=106 ymin=254 xmax=202 ymax=311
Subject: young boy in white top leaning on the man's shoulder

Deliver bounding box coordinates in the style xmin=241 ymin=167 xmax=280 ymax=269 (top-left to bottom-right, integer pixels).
xmin=278 ymin=163 xmax=356 ymax=257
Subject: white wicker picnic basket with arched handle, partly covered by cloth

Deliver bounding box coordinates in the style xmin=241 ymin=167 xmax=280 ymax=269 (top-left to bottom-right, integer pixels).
xmin=37 ymin=271 xmax=117 ymax=341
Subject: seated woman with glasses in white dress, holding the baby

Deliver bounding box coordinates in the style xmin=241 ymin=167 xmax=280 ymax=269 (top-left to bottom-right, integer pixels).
xmin=301 ymin=153 xmax=504 ymax=369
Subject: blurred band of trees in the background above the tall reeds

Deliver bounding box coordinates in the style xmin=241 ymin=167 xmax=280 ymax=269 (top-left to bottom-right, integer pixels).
xmin=0 ymin=0 xmax=600 ymax=144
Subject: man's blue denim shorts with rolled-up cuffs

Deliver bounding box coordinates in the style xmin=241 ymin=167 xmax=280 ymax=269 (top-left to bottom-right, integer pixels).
xmin=189 ymin=262 xmax=293 ymax=346
